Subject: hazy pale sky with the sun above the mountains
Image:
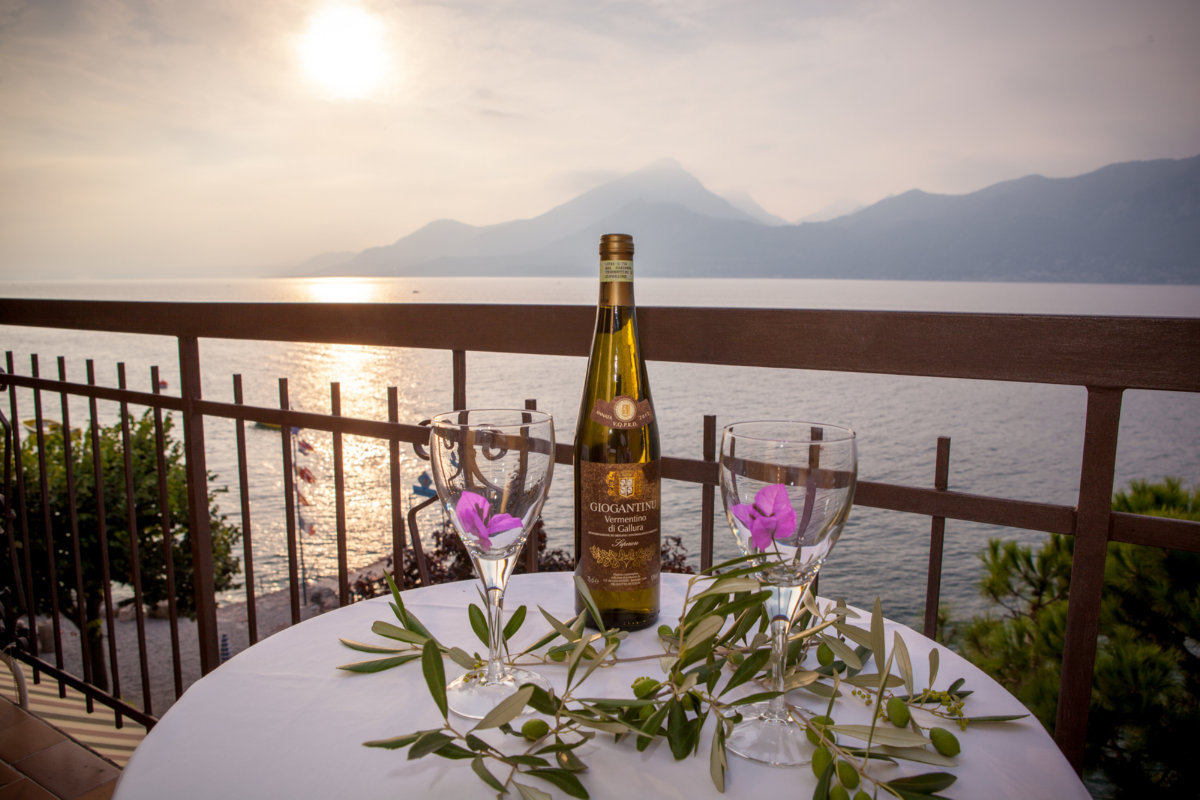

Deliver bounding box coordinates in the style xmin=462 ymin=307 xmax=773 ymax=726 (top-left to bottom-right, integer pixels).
xmin=0 ymin=0 xmax=1200 ymax=281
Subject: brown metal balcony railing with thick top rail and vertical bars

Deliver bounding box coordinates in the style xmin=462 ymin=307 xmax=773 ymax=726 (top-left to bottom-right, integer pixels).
xmin=0 ymin=300 xmax=1200 ymax=769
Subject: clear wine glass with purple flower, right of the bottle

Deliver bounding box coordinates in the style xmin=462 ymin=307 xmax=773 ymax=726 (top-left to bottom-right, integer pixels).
xmin=720 ymin=421 xmax=857 ymax=766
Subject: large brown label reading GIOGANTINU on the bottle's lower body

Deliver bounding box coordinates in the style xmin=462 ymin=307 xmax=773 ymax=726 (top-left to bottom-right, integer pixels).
xmin=580 ymin=461 xmax=661 ymax=591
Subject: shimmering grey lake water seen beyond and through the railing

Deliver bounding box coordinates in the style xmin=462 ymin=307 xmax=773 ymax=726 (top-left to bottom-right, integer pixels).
xmin=0 ymin=278 xmax=1200 ymax=622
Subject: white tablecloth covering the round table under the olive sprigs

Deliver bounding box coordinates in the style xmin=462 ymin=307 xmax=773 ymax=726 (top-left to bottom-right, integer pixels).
xmin=114 ymin=573 xmax=1088 ymax=800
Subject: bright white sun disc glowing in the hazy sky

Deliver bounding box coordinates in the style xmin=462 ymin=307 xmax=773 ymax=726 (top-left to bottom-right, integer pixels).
xmin=300 ymin=4 xmax=388 ymax=100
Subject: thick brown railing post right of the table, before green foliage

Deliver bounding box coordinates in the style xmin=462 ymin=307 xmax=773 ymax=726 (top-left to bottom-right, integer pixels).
xmin=1055 ymin=386 xmax=1123 ymax=772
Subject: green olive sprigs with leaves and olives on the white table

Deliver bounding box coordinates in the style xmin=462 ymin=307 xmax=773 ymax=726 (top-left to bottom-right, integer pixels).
xmin=340 ymin=557 xmax=1024 ymax=800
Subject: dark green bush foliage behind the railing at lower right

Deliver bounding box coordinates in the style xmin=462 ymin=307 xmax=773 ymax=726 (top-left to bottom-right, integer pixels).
xmin=954 ymin=479 xmax=1200 ymax=798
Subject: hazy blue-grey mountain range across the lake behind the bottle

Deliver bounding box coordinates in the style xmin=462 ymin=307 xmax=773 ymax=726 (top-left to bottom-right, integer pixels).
xmin=298 ymin=156 xmax=1200 ymax=283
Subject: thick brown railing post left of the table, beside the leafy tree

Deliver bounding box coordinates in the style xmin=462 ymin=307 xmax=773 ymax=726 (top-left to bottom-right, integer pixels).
xmin=179 ymin=336 xmax=221 ymax=675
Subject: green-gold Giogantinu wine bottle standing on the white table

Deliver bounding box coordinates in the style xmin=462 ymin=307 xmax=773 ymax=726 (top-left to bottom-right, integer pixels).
xmin=575 ymin=234 xmax=661 ymax=631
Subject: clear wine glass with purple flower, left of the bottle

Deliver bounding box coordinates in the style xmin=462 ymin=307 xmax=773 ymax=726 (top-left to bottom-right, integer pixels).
xmin=430 ymin=409 xmax=554 ymax=720
